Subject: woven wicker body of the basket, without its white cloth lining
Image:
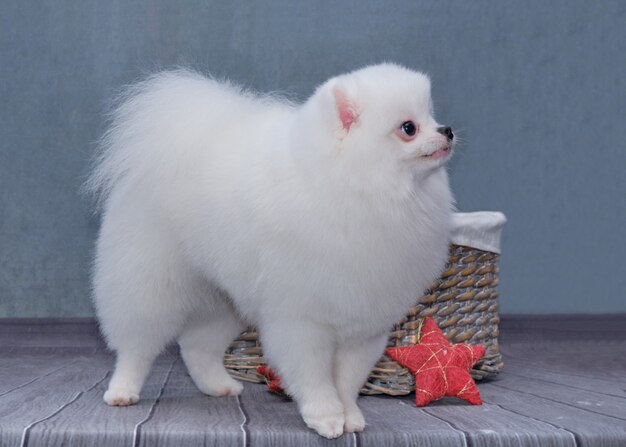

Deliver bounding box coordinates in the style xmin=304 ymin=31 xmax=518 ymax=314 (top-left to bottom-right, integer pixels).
xmin=224 ymin=244 xmax=503 ymax=395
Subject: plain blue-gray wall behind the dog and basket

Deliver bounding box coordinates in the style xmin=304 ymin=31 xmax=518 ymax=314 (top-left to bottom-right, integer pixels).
xmin=0 ymin=0 xmax=626 ymax=317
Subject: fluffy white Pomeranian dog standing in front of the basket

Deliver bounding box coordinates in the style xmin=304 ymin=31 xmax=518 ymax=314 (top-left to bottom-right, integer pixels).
xmin=87 ymin=64 xmax=454 ymax=438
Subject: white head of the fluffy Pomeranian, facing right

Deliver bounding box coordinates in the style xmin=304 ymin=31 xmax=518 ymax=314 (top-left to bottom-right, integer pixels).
xmin=305 ymin=64 xmax=454 ymax=191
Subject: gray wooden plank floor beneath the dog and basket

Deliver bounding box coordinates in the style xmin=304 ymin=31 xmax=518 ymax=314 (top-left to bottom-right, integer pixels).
xmin=0 ymin=315 xmax=626 ymax=447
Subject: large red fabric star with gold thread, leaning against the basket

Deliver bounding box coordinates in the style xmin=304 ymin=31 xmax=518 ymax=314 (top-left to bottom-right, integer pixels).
xmin=385 ymin=318 xmax=485 ymax=407
